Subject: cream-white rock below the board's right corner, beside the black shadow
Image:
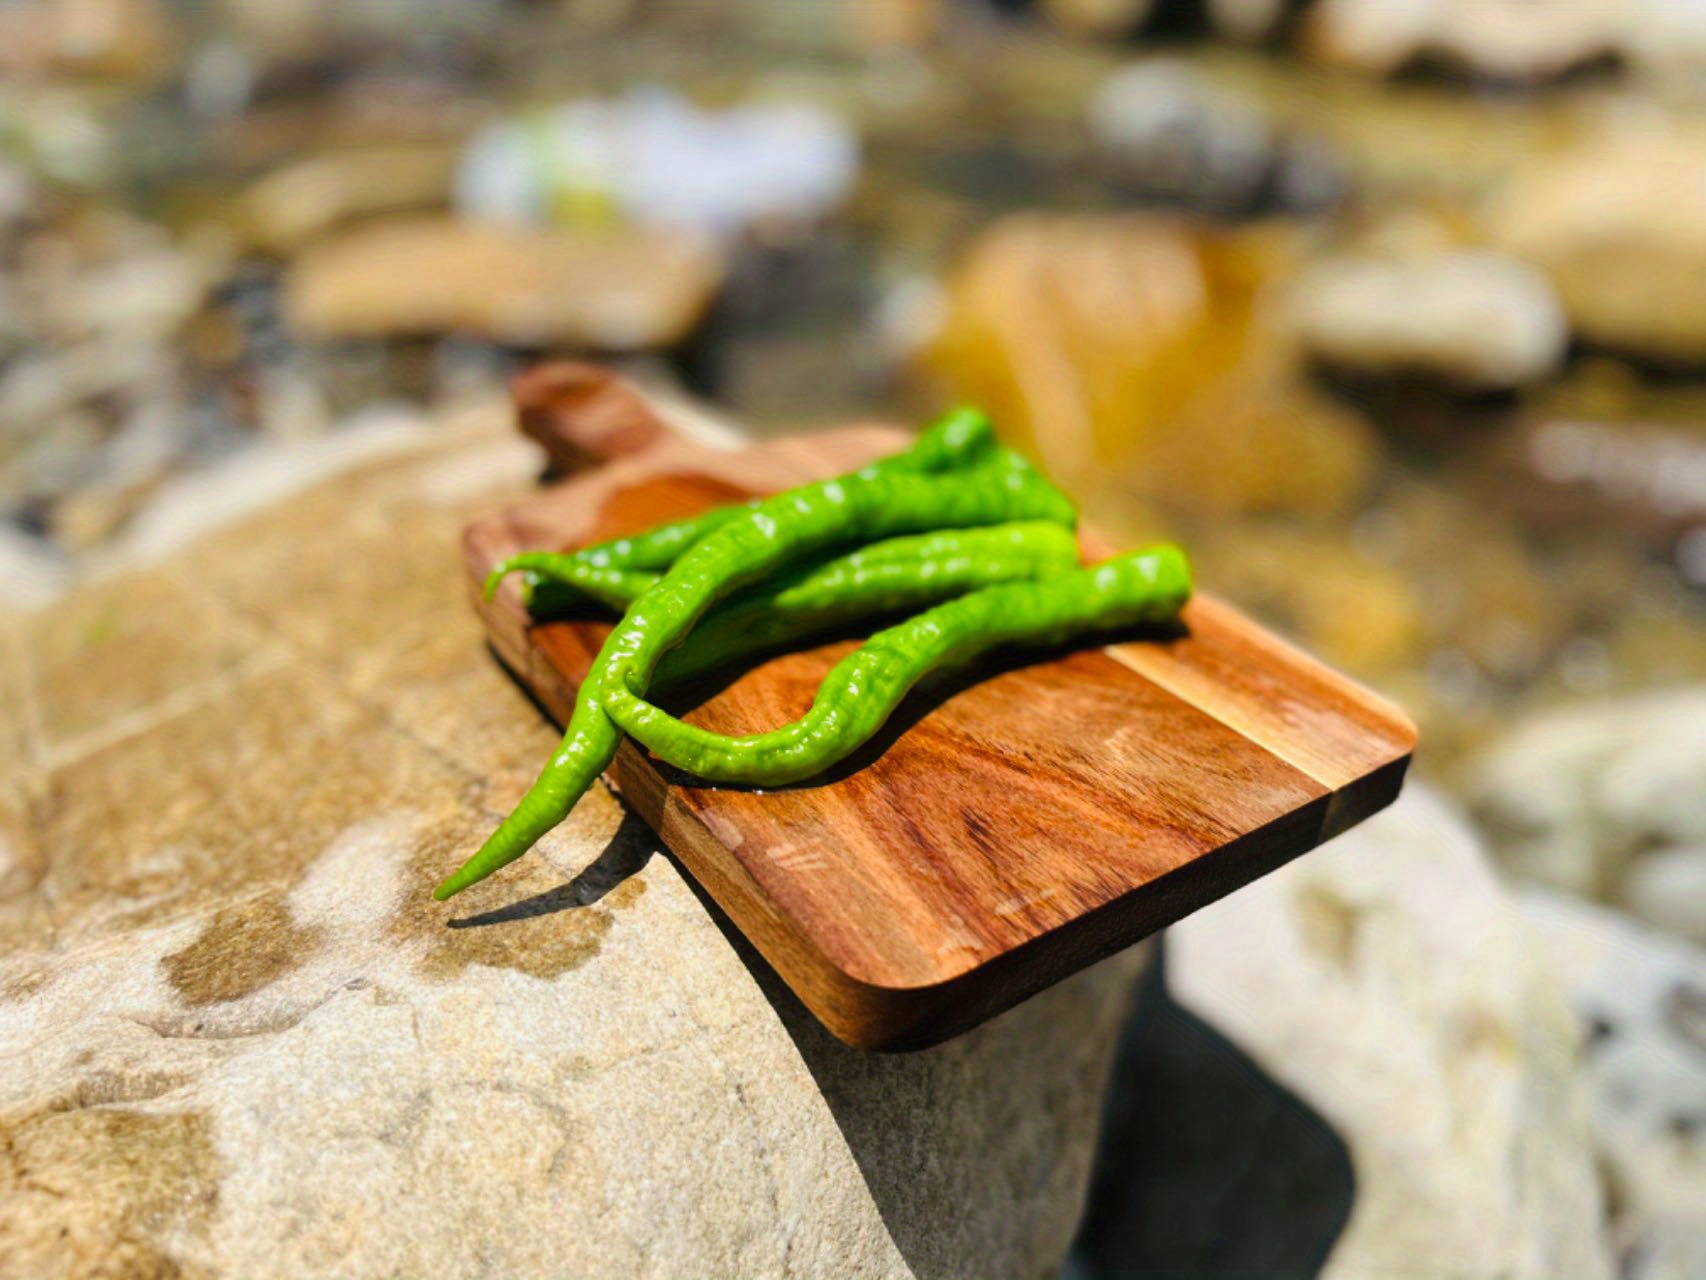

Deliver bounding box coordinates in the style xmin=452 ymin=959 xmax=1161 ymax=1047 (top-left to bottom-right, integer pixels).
xmin=1167 ymin=783 xmax=1610 ymax=1280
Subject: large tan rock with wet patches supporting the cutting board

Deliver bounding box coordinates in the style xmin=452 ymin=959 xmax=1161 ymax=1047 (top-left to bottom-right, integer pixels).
xmin=0 ymin=399 xmax=1140 ymax=1278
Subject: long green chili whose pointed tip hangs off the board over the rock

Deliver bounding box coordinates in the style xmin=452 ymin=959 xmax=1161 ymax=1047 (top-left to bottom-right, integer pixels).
xmin=433 ymin=451 xmax=1076 ymax=899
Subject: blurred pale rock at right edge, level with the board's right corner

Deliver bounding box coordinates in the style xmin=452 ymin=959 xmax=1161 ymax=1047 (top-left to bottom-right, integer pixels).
xmin=1467 ymin=686 xmax=1706 ymax=898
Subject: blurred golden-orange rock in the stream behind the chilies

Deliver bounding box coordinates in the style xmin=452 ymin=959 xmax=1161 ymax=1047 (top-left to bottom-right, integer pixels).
xmin=923 ymin=215 xmax=1375 ymax=512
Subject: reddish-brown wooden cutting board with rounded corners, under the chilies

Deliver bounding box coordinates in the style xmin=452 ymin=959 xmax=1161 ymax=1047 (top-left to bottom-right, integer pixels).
xmin=464 ymin=365 xmax=1416 ymax=1050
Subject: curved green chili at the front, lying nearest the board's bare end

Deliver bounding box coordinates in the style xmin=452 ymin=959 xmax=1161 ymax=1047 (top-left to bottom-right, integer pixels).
xmin=602 ymin=544 xmax=1191 ymax=787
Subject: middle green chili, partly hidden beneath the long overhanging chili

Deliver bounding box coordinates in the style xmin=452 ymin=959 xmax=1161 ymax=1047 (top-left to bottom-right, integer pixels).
xmin=505 ymin=521 xmax=1078 ymax=686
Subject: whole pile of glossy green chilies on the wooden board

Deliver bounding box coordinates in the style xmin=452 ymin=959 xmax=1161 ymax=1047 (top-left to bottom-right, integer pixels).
xmin=433 ymin=410 xmax=1191 ymax=899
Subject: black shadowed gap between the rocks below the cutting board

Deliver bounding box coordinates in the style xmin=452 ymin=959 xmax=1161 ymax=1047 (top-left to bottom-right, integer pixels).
xmin=1065 ymin=947 xmax=1355 ymax=1280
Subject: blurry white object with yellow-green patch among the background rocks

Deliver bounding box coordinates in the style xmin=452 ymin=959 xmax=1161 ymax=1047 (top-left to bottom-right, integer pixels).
xmin=456 ymin=89 xmax=858 ymax=236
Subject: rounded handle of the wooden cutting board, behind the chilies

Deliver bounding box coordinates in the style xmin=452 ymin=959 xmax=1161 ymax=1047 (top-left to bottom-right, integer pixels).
xmin=510 ymin=360 xmax=674 ymax=476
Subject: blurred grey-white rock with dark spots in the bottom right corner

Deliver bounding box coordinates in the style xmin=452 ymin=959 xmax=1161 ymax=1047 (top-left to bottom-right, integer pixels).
xmin=1523 ymin=893 xmax=1706 ymax=1280
